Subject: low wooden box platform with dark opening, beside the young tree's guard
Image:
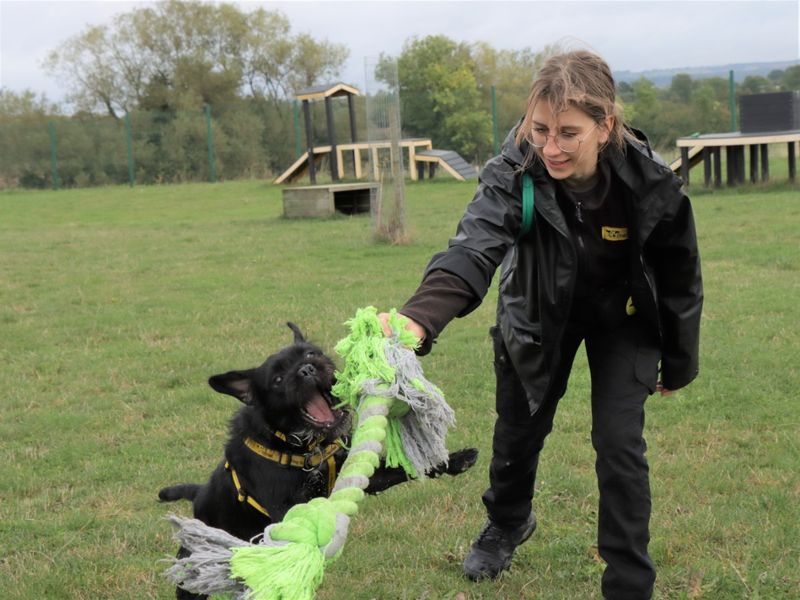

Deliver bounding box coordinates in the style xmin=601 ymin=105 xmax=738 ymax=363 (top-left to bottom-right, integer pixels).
xmin=283 ymin=183 xmax=381 ymax=219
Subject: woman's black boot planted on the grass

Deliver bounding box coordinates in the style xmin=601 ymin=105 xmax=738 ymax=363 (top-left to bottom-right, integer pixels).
xmin=464 ymin=513 xmax=536 ymax=581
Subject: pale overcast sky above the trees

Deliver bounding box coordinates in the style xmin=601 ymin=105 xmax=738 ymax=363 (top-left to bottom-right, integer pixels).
xmin=0 ymin=0 xmax=800 ymax=100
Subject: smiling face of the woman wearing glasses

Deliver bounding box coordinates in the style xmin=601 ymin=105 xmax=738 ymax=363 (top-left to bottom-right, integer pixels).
xmin=533 ymin=101 xmax=614 ymax=189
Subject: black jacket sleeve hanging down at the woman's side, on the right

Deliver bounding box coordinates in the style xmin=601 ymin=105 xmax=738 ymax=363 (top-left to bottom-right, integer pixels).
xmin=648 ymin=193 xmax=703 ymax=390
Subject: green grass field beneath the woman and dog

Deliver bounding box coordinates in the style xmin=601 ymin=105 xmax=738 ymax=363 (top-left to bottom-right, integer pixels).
xmin=0 ymin=176 xmax=800 ymax=600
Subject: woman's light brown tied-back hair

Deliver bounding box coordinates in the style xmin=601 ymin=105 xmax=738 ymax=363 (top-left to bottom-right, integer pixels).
xmin=516 ymin=50 xmax=632 ymax=156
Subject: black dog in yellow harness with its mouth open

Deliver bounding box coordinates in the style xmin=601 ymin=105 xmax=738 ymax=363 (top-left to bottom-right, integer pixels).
xmin=158 ymin=323 xmax=478 ymax=598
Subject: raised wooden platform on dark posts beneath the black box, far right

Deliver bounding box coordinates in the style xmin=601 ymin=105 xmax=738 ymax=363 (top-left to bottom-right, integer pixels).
xmin=671 ymin=129 xmax=800 ymax=187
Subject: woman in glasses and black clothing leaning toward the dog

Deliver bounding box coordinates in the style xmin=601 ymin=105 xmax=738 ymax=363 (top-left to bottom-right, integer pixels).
xmin=384 ymin=51 xmax=703 ymax=599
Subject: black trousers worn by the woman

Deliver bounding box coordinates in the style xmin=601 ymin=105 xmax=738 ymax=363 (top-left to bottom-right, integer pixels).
xmin=483 ymin=315 xmax=660 ymax=600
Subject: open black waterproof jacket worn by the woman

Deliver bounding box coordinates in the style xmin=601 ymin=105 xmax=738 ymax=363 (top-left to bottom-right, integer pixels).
xmin=426 ymin=130 xmax=703 ymax=413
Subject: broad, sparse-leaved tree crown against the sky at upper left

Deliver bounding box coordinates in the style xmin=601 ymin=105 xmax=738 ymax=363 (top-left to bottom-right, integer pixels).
xmin=45 ymin=0 xmax=348 ymax=117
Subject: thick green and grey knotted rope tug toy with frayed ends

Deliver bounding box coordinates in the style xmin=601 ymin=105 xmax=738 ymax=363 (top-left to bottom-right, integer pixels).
xmin=164 ymin=306 xmax=455 ymax=600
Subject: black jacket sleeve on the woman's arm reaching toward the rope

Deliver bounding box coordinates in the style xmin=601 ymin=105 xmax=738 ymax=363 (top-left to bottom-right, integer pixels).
xmin=425 ymin=156 xmax=522 ymax=317
